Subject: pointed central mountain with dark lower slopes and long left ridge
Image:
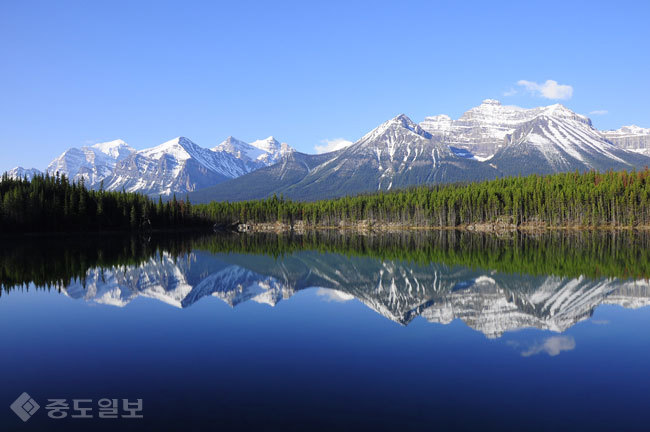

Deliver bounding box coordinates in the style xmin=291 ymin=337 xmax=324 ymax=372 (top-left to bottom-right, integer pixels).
xmin=191 ymin=114 xmax=498 ymax=202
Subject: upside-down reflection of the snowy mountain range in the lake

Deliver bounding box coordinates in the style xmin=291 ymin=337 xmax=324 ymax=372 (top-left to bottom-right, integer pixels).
xmin=65 ymin=251 xmax=650 ymax=337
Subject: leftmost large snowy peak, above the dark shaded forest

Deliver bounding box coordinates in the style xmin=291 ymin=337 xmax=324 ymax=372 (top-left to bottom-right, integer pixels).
xmin=46 ymin=139 xmax=135 ymax=187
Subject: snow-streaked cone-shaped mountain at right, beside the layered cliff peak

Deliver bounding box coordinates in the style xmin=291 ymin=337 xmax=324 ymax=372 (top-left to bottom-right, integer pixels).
xmin=489 ymin=104 xmax=650 ymax=175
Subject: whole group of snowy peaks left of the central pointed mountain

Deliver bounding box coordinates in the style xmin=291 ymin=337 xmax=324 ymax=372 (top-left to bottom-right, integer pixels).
xmin=36 ymin=137 xmax=293 ymax=196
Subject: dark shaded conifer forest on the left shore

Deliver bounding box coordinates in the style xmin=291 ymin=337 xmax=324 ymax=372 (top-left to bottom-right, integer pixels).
xmin=0 ymin=174 xmax=209 ymax=233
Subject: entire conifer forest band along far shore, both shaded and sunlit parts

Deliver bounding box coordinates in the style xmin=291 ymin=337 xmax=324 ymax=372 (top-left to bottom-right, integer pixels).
xmin=5 ymin=168 xmax=650 ymax=233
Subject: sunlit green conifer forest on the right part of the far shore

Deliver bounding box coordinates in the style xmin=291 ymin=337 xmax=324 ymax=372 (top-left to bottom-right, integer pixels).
xmin=194 ymin=168 xmax=650 ymax=227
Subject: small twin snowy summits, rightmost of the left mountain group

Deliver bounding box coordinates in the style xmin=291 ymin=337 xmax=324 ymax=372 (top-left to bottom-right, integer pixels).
xmin=212 ymin=136 xmax=294 ymax=171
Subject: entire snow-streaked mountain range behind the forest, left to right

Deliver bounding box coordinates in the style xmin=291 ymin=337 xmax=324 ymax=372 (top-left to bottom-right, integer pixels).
xmin=9 ymin=99 xmax=650 ymax=202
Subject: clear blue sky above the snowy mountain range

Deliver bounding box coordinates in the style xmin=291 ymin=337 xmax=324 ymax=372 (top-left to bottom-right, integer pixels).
xmin=0 ymin=1 xmax=650 ymax=171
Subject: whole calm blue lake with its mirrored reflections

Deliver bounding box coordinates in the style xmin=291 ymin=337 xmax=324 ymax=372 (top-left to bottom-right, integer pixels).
xmin=0 ymin=231 xmax=650 ymax=431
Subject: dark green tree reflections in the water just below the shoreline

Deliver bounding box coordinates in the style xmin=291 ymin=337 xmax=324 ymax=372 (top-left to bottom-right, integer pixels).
xmin=0 ymin=231 xmax=650 ymax=291
